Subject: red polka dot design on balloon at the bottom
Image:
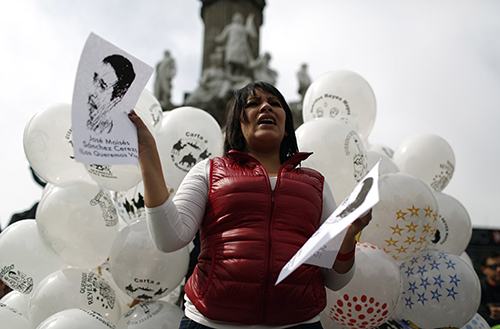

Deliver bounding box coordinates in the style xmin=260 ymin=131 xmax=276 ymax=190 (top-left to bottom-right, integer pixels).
xmin=328 ymin=294 xmax=389 ymax=329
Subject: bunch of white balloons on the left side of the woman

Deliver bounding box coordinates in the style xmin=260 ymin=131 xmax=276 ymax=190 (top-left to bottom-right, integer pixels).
xmin=0 ymin=90 xmax=222 ymax=329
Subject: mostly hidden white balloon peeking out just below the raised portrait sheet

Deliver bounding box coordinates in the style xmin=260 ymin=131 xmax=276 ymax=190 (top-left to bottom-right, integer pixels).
xmin=85 ymin=164 xmax=142 ymax=191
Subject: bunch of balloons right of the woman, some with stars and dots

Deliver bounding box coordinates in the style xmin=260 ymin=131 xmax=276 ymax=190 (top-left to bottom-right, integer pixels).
xmin=296 ymin=70 xmax=480 ymax=329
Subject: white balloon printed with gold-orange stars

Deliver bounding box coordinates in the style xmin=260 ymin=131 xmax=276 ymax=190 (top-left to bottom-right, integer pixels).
xmin=359 ymin=173 xmax=438 ymax=261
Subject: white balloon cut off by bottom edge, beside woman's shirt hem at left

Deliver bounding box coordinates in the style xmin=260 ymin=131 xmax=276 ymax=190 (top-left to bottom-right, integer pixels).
xmin=116 ymin=300 xmax=184 ymax=329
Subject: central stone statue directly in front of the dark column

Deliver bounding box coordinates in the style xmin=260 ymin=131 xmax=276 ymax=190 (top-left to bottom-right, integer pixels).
xmin=215 ymin=12 xmax=257 ymax=76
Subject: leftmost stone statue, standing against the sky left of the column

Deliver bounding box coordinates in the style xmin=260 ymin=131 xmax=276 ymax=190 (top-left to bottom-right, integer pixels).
xmin=154 ymin=50 xmax=177 ymax=111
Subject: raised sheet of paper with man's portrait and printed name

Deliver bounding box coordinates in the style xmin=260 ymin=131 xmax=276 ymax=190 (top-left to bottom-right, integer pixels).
xmin=71 ymin=33 xmax=154 ymax=165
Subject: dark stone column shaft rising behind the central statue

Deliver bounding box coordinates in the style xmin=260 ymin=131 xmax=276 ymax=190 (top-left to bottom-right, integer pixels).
xmin=200 ymin=0 xmax=266 ymax=72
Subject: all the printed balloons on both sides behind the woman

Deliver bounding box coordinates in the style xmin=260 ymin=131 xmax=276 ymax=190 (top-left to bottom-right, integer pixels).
xmin=0 ymin=70 xmax=487 ymax=329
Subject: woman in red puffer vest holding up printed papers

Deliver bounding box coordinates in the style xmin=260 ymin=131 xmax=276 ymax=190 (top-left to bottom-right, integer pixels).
xmin=130 ymin=82 xmax=371 ymax=329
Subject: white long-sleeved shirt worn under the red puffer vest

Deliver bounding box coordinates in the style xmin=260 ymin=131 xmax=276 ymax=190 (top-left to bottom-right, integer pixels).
xmin=146 ymin=159 xmax=355 ymax=329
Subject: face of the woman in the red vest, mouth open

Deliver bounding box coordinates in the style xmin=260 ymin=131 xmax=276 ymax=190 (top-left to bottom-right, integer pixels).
xmin=241 ymin=89 xmax=286 ymax=153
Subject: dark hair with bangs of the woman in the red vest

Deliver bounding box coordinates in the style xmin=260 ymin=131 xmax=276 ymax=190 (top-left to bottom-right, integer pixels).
xmin=224 ymin=81 xmax=299 ymax=163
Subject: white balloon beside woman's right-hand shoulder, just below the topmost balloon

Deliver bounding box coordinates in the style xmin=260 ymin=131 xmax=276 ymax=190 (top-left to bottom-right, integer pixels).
xmin=295 ymin=118 xmax=367 ymax=204
